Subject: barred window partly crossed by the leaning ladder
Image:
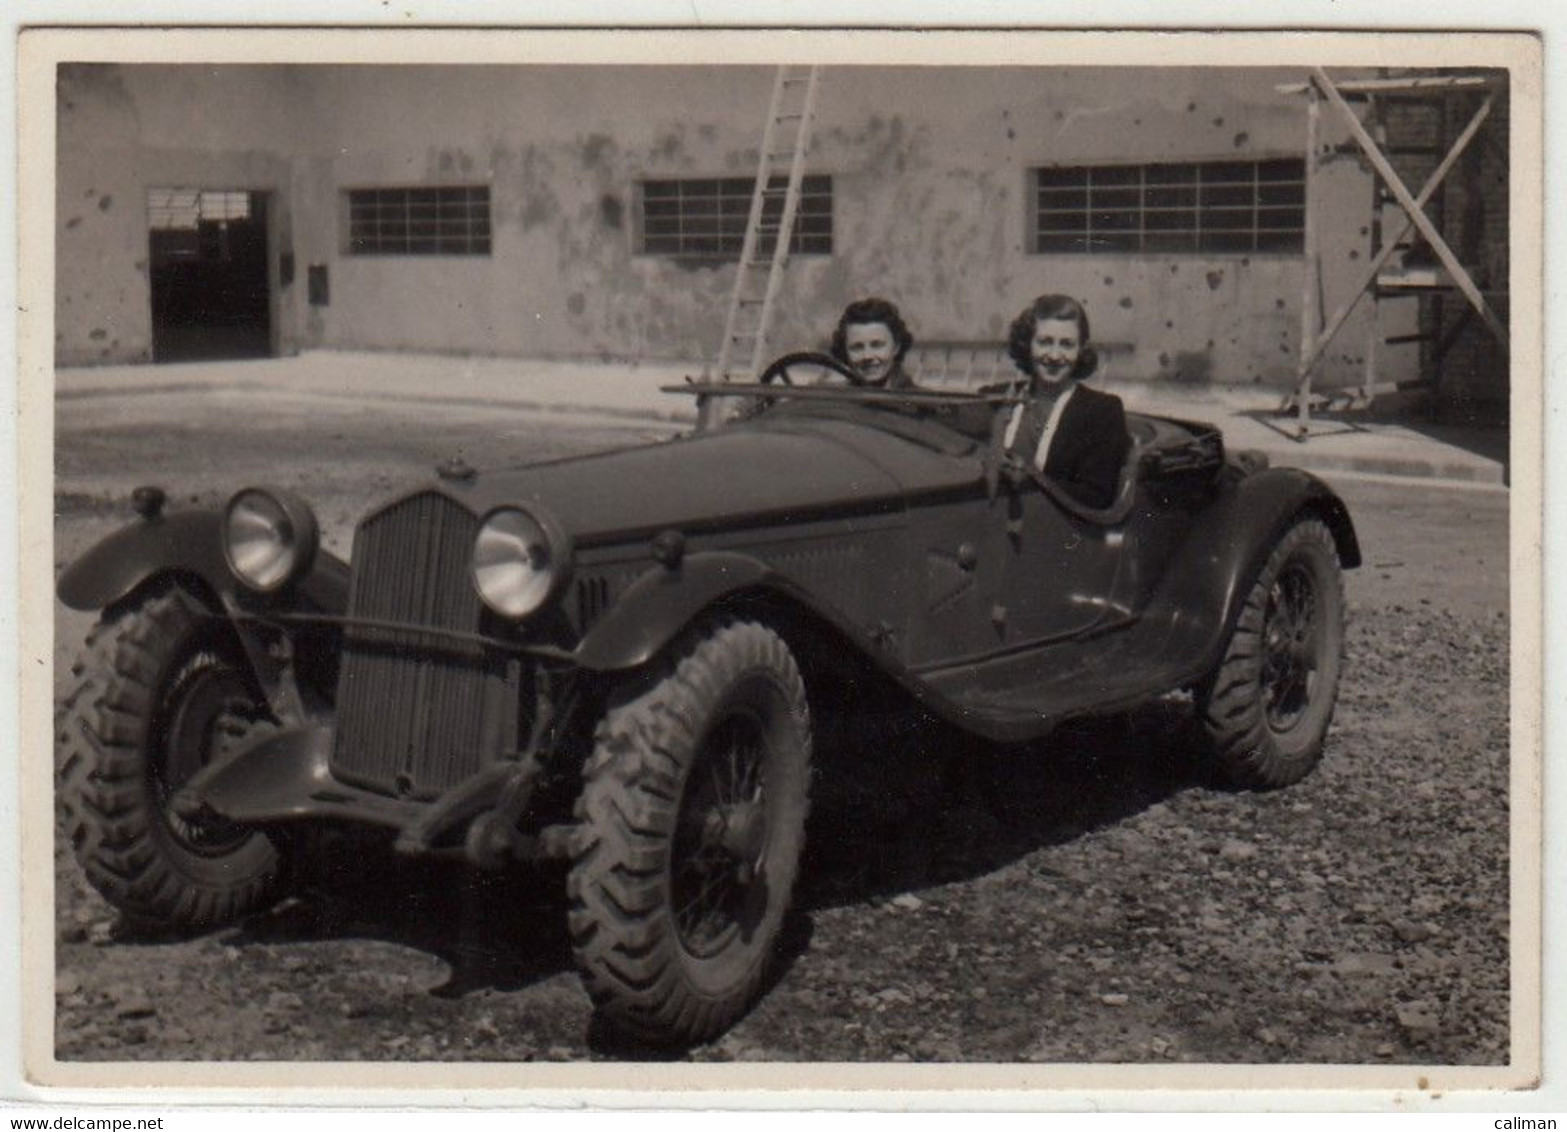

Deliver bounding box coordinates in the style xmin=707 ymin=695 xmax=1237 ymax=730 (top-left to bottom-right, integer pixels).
xmin=639 ymin=174 xmax=832 ymax=259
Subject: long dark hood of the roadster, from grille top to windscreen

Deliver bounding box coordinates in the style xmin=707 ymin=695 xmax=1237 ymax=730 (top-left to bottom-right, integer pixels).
xmin=423 ymin=422 xmax=978 ymax=546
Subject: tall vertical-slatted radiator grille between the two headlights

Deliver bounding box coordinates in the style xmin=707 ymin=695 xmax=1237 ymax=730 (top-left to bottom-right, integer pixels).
xmin=332 ymin=492 xmax=522 ymax=798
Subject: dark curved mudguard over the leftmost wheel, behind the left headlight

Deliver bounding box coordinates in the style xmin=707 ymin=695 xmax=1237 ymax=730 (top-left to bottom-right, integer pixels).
xmin=55 ymin=511 xmax=348 ymax=613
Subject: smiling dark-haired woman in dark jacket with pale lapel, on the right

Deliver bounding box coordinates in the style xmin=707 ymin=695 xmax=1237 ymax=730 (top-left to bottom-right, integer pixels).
xmin=1001 ymin=295 xmax=1131 ymax=508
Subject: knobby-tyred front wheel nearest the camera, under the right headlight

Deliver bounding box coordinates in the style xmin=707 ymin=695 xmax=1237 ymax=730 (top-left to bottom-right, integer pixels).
xmin=567 ymin=622 xmax=810 ymax=1046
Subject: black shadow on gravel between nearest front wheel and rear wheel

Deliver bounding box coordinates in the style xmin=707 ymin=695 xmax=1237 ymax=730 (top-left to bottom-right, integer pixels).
xmin=796 ymin=699 xmax=1227 ymax=911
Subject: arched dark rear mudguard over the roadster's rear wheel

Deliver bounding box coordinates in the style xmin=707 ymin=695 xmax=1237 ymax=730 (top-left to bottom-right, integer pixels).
xmin=1145 ymin=469 xmax=1360 ymax=671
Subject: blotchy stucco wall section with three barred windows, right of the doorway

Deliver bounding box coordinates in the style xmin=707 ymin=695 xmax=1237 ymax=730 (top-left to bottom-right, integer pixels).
xmin=285 ymin=67 xmax=1397 ymax=384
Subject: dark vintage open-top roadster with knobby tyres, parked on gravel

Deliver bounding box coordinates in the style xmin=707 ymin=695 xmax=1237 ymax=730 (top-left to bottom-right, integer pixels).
xmin=58 ymin=356 xmax=1359 ymax=1043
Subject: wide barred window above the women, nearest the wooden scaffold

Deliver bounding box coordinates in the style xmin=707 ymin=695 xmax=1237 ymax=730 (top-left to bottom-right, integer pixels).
xmin=1033 ymin=157 xmax=1305 ymax=252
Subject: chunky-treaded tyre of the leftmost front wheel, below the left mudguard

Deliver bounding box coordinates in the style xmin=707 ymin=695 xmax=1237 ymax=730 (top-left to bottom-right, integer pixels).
xmin=56 ymin=586 xmax=282 ymax=928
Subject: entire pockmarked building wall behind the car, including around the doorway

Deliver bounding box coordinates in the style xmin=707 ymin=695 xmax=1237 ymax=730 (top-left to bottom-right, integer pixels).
xmin=56 ymin=66 xmax=1410 ymax=387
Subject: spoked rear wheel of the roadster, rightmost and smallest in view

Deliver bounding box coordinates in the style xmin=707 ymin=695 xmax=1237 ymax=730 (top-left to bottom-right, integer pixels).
xmin=1197 ymin=519 xmax=1344 ymax=789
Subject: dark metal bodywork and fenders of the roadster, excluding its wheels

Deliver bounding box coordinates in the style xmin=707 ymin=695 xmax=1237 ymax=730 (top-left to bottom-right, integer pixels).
xmin=60 ymin=388 xmax=1359 ymax=825
